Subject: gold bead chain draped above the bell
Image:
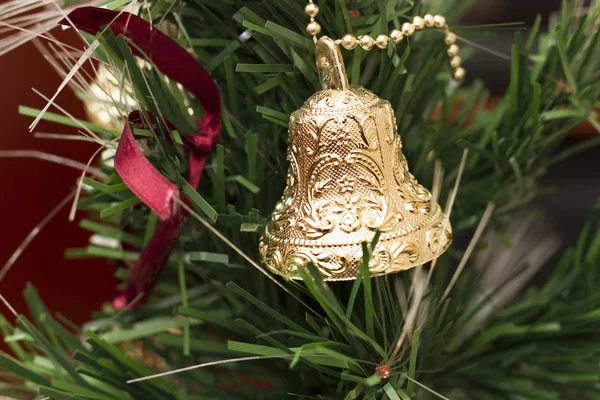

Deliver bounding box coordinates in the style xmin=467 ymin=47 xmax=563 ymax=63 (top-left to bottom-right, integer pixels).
xmin=304 ymin=0 xmax=466 ymax=81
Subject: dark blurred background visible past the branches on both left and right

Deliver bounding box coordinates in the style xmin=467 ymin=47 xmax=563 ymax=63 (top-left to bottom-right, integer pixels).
xmin=0 ymin=0 xmax=600 ymax=322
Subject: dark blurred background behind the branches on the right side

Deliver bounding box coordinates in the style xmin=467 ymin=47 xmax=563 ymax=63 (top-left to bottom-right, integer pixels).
xmin=464 ymin=0 xmax=600 ymax=250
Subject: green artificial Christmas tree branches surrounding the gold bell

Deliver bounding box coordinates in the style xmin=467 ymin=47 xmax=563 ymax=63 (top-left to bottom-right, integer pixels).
xmin=0 ymin=0 xmax=600 ymax=400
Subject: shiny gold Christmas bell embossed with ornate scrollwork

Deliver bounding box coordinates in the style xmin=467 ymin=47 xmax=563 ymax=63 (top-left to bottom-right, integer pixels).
xmin=260 ymin=37 xmax=452 ymax=281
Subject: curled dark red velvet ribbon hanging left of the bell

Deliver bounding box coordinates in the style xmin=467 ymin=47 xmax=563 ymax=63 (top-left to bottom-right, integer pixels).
xmin=60 ymin=7 xmax=222 ymax=309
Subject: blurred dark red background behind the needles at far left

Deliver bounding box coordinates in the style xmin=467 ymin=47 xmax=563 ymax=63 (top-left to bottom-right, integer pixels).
xmin=0 ymin=32 xmax=114 ymax=322
